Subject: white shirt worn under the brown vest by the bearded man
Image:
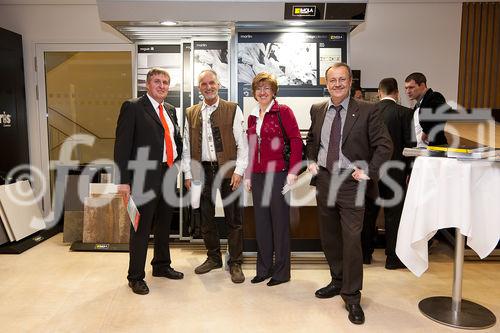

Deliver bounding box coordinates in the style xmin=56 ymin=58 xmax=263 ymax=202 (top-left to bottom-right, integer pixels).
xmin=182 ymin=98 xmax=248 ymax=179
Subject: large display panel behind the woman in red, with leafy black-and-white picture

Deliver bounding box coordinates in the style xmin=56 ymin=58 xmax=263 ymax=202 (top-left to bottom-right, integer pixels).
xmin=237 ymin=32 xmax=347 ymax=130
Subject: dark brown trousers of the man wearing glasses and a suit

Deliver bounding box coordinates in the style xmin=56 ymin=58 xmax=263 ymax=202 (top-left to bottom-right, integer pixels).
xmin=316 ymin=168 xmax=364 ymax=304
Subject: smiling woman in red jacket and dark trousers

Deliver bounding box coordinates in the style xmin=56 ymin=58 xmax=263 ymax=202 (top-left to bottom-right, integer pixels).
xmin=245 ymin=72 xmax=302 ymax=286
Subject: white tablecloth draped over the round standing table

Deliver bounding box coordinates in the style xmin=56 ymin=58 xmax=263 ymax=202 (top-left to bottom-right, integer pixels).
xmin=396 ymin=157 xmax=500 ymax=276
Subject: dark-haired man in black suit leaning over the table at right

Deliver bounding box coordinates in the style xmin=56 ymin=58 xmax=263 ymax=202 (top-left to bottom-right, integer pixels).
xmin=405 ymin=72 xmax=451 ymax=147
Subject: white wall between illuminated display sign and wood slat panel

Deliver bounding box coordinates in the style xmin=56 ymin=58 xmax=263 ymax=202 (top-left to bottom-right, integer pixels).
xmin=350 ymin=2 xmax=462 ymax=105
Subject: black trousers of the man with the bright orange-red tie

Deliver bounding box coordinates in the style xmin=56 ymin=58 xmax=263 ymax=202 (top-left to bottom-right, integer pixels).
xmin=127 ymin=163 xmax=174 ymax=281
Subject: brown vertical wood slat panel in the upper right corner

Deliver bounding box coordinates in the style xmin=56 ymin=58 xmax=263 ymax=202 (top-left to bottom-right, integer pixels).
xmin=458 ymin=2 xmax=500 ymax=109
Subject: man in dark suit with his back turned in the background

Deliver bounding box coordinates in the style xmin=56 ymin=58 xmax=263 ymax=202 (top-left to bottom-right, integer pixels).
xmin=361 ymin=78 xmax=413 ymax=269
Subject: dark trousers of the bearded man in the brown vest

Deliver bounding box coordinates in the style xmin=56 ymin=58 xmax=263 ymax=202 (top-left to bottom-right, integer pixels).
xmin=200 ymin=164 xmax=243 ymax=265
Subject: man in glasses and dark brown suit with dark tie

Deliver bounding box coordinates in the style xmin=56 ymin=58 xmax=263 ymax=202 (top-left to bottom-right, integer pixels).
xmin=306 ymin=63 xmax=392 ymax=324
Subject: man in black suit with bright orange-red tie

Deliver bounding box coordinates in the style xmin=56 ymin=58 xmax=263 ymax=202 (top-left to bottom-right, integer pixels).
xmin=114 ymin=68 xmax=183 ymax=295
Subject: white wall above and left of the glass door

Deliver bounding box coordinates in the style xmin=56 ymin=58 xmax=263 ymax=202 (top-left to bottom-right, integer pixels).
xmin=0 ymin=4 xmax=130 ymax=210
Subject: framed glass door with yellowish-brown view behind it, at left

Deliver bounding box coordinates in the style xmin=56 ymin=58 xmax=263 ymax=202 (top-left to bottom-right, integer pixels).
xmin=34 ymin=45 xmax=135 ymax=223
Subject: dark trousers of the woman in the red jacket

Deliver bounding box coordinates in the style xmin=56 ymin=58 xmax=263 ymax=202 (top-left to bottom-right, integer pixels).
xmin=252 ymin=171 xmax=290 ymax=281
